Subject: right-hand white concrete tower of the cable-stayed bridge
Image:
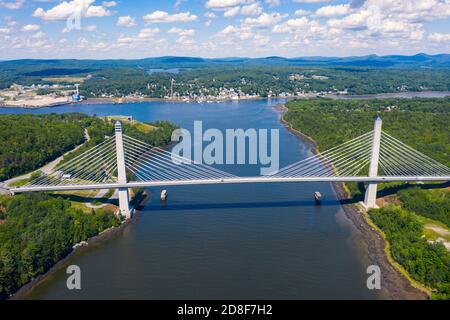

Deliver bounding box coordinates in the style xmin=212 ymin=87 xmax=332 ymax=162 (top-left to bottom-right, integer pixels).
xmin=364 ymin=117 xmax=383 ymax=209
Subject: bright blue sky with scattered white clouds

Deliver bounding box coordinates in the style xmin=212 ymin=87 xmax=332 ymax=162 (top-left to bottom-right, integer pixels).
xmin=0 ymin=0 xmax=450 ymax=60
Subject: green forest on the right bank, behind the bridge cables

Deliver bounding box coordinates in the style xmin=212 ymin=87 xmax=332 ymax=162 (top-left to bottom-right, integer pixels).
xmin=285 ymin=98 xmax=450 ymax=166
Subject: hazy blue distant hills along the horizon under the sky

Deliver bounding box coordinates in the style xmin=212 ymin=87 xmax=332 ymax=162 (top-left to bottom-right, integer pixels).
xmin=0 ymin=53 xmax=450 ymax=68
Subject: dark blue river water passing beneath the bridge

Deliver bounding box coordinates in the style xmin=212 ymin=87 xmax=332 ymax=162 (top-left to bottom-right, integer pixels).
xmin=0 ymin=100 xmax=382 ymax=299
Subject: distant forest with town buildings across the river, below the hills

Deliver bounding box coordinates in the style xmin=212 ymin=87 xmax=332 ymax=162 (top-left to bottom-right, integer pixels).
xmin=0 ymin=59 xmax=450 ymax=98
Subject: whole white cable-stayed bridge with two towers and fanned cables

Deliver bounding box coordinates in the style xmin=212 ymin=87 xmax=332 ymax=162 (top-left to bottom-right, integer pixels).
xmin=10 ymin=118 xmax=450 ymax=218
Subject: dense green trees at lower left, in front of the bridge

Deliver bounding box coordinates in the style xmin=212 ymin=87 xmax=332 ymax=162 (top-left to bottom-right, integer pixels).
xmin=0 ymin=194 xmax=120 ymax=299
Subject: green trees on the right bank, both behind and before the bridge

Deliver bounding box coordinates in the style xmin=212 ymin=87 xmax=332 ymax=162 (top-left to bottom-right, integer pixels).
xmin=285 ymin=98 xmax=450 ymax=299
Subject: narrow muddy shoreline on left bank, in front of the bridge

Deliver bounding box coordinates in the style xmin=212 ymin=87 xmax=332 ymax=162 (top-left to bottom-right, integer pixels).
xmin=9 ymin=191 xmax=151 ymax=300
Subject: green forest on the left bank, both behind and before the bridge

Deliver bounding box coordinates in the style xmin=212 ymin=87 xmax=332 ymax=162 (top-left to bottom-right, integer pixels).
xmin=0 ymin=113 xmax=177 ymax=300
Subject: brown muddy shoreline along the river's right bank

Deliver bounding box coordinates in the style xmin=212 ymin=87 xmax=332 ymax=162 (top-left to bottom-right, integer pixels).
xmin=277 ymin=105 xmax=429 ymax=300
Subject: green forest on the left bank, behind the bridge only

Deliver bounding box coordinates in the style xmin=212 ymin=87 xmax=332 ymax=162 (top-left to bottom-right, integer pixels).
xmin=0 ymin=113 xmax=176 ymax=181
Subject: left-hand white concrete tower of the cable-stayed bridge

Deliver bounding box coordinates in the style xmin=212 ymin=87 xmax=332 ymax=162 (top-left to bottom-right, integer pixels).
xmin=115 ymin=121 xmax=131 ymax=219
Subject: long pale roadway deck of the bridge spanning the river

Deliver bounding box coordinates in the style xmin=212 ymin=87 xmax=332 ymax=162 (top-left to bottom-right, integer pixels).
xmin=10 ymin=176 xmax=450 ymax=194
